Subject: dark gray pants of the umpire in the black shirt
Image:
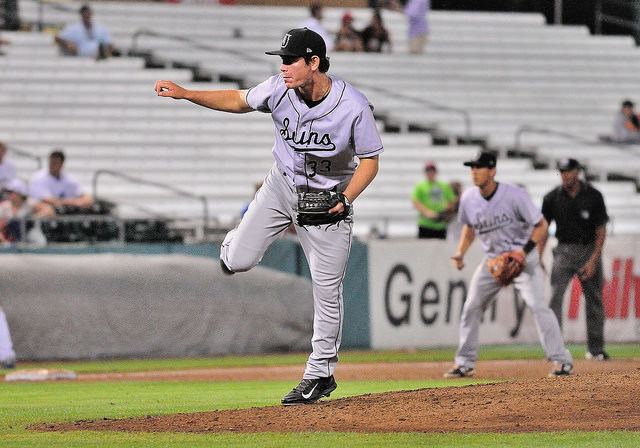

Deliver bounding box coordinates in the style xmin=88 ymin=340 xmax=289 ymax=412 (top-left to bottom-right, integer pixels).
xmin=549 ymin=243 xmax=604 ymax=354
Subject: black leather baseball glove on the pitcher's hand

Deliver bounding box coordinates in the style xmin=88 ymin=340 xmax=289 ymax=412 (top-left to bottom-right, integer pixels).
xmin=296 ymin=191 xmax=350 ymax=226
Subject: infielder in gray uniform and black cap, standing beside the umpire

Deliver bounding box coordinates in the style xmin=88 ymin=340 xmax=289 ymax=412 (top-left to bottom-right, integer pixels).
xmin=445 ymin=151 xmax=573 ymax=378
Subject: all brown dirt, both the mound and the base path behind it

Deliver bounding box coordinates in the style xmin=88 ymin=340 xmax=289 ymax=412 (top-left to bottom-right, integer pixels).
xmin=31 ymin=360 xmax=640 ymax=433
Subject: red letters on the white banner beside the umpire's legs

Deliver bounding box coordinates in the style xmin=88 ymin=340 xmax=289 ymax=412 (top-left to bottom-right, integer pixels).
xmin=568 ymin=258 xmax=640 ymax=320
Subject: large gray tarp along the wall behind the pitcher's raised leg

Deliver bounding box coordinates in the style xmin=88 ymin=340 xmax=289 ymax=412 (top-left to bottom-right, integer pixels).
xmin=0 ymin=254 xmax=313 ymax=359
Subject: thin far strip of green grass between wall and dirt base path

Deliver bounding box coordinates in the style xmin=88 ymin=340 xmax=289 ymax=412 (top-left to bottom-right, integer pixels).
xmin=13 ymin=344 xmax=640 ymax=373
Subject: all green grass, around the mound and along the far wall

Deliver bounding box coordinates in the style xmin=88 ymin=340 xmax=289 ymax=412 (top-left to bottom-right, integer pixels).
xmin=0 ymin=345 xmax=640 ymax=448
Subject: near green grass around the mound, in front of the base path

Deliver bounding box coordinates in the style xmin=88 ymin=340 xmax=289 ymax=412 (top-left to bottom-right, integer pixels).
xmin=0 ymin=381 xmax=640 ymax=448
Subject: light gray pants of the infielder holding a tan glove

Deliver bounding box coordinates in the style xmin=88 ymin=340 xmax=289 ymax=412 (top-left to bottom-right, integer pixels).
xmin=455 ymin=250 xmax=573 ymax=368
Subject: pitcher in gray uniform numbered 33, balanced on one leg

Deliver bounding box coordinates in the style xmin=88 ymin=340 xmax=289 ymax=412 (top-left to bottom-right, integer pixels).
xmin=155 ymin=28 xmax=382 ymax=405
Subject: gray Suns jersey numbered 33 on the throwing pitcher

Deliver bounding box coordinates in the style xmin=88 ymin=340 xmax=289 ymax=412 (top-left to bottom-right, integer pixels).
xmin=245 ymin=74 xmax=383 ymax=190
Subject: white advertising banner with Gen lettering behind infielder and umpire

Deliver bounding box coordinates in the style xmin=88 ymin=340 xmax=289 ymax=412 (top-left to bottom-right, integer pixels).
xmin=369 ymin=237 xmax=640 ymax=349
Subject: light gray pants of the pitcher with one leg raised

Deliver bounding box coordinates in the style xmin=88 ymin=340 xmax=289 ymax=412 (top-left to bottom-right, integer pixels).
xmin=220 ymin=165 xmax=352 ymax=378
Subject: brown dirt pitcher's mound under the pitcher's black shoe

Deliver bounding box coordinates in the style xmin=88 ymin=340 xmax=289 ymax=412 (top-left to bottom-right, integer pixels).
xmin=32 ymin=368 xmax=640 ymax=432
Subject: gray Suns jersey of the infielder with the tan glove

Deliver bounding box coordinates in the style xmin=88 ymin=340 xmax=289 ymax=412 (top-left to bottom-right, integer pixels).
xmin=458 ymin=182 xmax=542 ymax=257
